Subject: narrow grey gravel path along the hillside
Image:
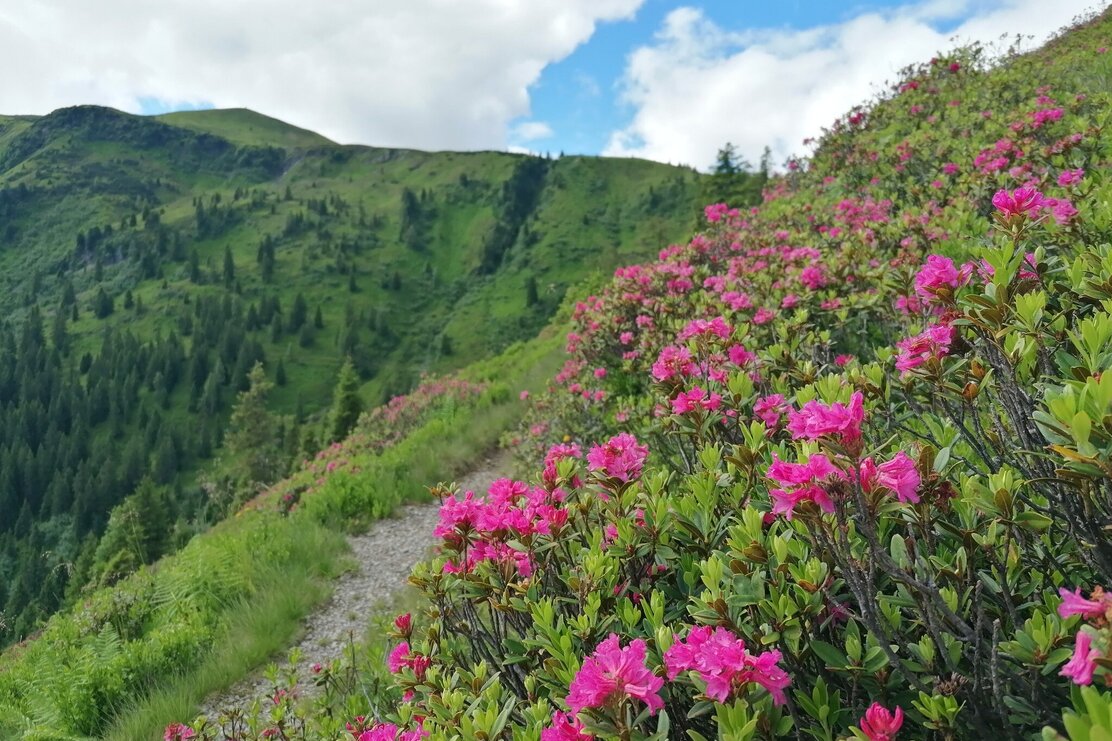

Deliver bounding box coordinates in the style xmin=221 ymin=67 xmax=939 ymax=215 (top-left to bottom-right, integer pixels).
xmin=201 ymin=451 xmax=512 ymax=721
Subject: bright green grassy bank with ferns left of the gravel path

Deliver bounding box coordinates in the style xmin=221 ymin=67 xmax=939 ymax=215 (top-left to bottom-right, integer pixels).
xmin=0 ymin=334 xmax=559 ymax=739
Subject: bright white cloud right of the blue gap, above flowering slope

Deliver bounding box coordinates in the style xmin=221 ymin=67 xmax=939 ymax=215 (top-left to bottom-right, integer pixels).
xmin=605 ymin=0 xmax=1104 ymax=168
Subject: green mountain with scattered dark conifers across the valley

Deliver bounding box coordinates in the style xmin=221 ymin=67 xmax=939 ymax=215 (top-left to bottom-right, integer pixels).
xmin=0 ymin=106 xmax=720 ymax=641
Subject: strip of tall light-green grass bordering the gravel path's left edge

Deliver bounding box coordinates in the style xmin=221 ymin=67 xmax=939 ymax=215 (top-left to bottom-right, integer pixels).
xmin=82 ymin=334 xmax=562 ymax=741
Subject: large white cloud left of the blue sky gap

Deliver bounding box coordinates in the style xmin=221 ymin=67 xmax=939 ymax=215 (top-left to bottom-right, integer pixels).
xmin=0 ymin=0 xmax=644 ymax=149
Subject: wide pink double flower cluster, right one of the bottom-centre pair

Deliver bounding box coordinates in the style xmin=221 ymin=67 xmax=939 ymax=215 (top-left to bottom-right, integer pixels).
xmin=664 ymin=626 xmax=792 ymax=705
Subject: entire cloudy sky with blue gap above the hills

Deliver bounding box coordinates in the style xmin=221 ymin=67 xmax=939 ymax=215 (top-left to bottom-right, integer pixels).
xmin=0 ymin=0 xmax=1108 ymax=169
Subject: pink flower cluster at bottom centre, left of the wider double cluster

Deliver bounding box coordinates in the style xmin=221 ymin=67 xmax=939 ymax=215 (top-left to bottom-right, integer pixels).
xmin=566 ymin=633 xmax=664 ymax=714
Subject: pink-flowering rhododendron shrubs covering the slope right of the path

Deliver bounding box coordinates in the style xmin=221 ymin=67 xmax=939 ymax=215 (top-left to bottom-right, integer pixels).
xmin=169 ymin=10 xmax=1112 ymax=741
